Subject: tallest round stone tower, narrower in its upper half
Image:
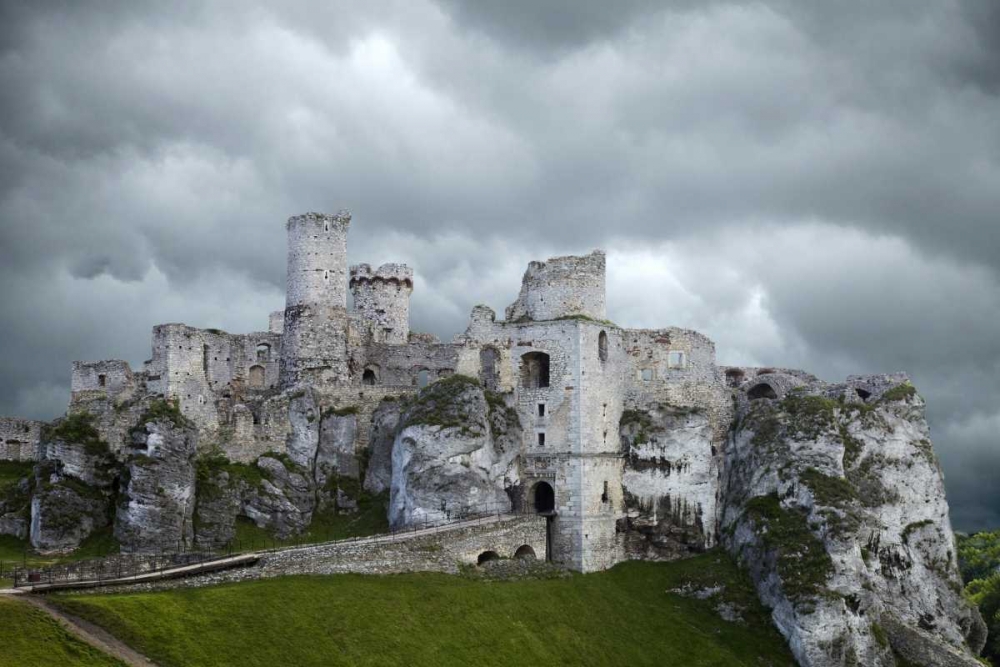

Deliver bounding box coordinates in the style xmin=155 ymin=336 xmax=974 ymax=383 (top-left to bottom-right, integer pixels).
xmin=281 ymin=211 xmax=351 ymax=387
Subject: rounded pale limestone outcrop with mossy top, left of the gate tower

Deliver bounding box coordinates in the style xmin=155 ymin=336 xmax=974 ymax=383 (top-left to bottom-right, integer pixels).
xmin=389 ymin=375 xmax=520 ymax=527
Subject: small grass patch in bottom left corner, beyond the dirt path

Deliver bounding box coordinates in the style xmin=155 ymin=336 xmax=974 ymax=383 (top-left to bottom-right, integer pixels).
xmin=0 ymin=597 xmax=123 ymax=667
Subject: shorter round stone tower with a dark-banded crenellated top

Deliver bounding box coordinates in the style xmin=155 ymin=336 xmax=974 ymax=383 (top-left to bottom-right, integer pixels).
xmin=350 ymin=264 xmax=413 ymax=345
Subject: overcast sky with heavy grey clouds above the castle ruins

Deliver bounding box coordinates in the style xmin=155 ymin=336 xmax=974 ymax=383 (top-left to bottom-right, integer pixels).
xmin=0 ymin=0 xmax=1000 ymax=530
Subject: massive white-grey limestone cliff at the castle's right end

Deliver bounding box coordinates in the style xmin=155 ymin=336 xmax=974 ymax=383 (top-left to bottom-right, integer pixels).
xmin=722 ymin=377 xmax=985 ymax=667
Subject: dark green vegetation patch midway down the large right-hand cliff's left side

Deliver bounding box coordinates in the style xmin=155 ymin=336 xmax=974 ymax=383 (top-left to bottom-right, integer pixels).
xmin=746 ymin=494 xmax=833 ymax=603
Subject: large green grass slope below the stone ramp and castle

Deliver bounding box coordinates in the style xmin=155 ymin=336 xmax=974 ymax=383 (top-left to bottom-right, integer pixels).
xmin=53 ymin=552 xmax=794 ymax=667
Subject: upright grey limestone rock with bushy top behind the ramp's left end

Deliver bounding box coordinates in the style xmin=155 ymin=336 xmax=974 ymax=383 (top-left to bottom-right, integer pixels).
xmin=115 ymin=408 xmax=198 ymax=551
